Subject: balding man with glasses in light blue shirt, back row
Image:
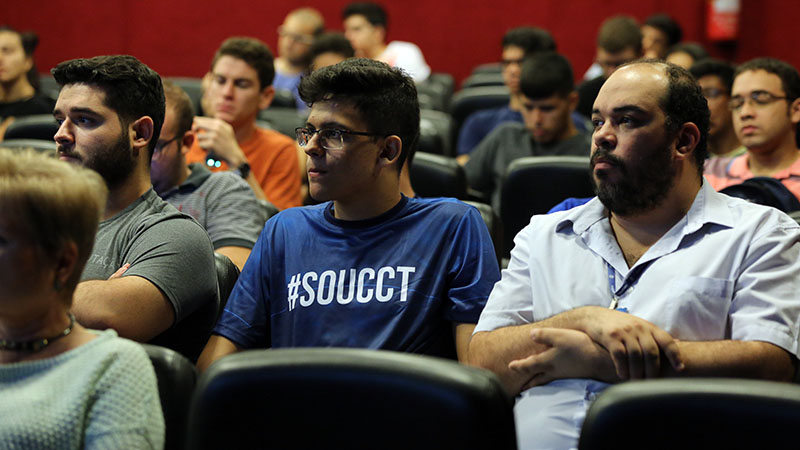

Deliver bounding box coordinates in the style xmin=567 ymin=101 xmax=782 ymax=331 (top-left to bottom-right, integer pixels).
xmin=272 ymin=8 xmax=325 ymax=111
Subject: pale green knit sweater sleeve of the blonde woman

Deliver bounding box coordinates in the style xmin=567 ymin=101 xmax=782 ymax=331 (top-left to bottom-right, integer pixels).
xmin=84 ymin=340 xmax=164 ymax=449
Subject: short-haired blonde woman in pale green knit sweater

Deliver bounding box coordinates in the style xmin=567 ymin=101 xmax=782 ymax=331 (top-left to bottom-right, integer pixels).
xmin=0 ymin=149 xmax=164 ymax=449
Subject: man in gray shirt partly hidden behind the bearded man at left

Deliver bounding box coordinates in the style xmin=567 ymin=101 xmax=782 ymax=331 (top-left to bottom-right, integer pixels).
xmin=150 ymin=80 xmax=268 ymax=270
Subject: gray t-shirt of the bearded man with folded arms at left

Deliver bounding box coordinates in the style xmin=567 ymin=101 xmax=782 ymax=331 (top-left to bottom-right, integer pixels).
xmin=81 ymin=188 xmax=217 ymax=323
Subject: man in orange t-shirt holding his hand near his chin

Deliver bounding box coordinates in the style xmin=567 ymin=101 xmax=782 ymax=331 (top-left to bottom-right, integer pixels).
xmin=186 ymin=37 xmax=301 ymax=209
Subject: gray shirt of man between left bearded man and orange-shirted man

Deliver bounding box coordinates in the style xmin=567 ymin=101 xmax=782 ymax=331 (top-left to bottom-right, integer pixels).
xmin=161 ymin=163 xmax=269 ymax=249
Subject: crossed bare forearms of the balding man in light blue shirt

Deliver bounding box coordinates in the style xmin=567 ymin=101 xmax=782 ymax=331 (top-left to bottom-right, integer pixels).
xmin=469 ymin=306 xmax=795 ymax=394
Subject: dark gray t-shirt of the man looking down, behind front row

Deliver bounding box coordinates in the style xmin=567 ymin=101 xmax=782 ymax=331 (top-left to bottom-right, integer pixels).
xmin=464 ymin=122 xmax=591 ymax=211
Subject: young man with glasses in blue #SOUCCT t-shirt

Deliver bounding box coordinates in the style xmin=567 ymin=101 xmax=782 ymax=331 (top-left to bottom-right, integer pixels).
xmin=198 ymin=59 xmax=500 ymax=369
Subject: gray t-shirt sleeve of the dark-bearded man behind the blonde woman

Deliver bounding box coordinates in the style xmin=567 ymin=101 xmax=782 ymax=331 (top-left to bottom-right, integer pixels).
xmin=123 ymin=214 xmax=217 ymax=323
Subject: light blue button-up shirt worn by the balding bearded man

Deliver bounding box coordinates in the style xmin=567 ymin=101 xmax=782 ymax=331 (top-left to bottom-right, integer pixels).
xmin=475 ymin=182 xmax=800 ymax=448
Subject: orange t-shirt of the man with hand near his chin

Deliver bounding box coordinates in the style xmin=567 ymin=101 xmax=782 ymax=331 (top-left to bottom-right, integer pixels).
xmin=186 ymin=128 xmax=303 ymax=209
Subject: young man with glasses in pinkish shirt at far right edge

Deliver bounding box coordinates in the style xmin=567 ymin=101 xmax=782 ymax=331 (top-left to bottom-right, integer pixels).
xmin=705 ymin=58 xmax=800 ymax=198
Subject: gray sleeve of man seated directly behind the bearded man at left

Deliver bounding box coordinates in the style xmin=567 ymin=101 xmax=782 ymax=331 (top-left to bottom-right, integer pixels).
xmin=206 ymin=173 xmax=266 ymax=250
